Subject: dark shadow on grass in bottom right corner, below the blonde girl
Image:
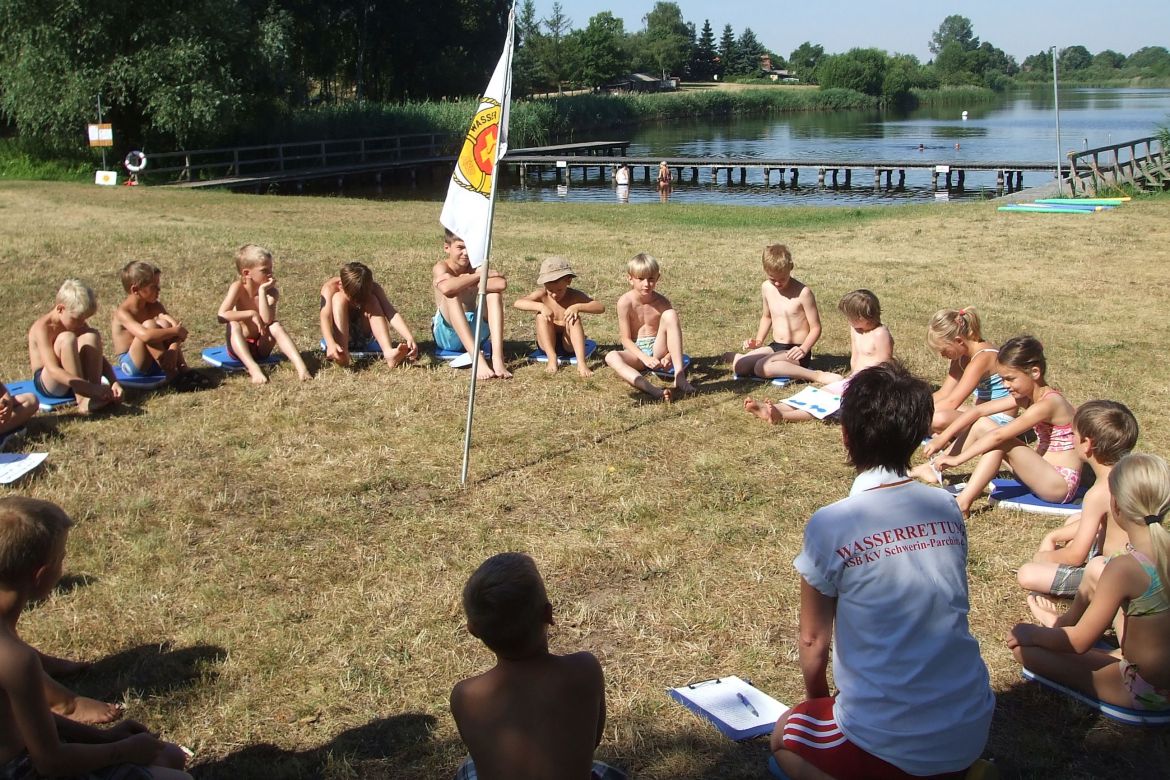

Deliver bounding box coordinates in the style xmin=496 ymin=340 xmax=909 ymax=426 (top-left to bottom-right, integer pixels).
xmin=984 ymin=679 xmax=1170 ymax=780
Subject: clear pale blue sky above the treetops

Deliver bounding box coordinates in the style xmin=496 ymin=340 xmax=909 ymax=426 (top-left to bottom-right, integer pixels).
xmin=545 ymin=0 xmax=1170 ymax=62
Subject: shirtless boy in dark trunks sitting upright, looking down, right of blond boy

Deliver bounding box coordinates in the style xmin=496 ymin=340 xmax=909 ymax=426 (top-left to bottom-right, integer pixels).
xmin=724 ymin=243 xmax=840 ymax=384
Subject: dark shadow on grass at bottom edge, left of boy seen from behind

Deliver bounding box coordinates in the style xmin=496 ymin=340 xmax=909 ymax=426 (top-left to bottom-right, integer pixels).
xmin=190 ymin=712 xmax=444 ymax=780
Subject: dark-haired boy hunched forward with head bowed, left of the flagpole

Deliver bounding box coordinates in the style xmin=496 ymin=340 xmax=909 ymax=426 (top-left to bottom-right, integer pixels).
xmin=321 ymin=263 xmax=419 ymax=368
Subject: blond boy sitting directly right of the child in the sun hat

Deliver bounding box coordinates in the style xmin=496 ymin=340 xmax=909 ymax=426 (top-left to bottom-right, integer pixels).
xmin=605 ymin=253 xmax=695 ymax=403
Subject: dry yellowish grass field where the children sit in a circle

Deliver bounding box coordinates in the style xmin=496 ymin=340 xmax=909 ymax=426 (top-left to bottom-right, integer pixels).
xmin=0 ymin=184 xmax=1170 ymax=780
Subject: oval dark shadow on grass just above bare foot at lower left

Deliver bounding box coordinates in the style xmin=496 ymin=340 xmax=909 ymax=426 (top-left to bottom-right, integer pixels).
xmin=71 ymin=643 xmax=227 ymax=702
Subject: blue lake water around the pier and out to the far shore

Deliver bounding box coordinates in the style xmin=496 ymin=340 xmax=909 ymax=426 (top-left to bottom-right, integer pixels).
xmin=360 ymin=88 xmax=1170 ymax=205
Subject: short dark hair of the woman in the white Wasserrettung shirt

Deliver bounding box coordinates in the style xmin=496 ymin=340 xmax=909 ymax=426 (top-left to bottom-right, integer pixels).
xmin=841 ymin=360 xmax=934 ymax=474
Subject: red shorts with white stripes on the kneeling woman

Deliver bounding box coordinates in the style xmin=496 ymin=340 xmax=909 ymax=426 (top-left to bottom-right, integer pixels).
xmin=783 ymin=698 xmax=966 ymax=780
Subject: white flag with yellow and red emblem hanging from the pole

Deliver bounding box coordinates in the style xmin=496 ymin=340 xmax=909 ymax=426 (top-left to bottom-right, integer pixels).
xmin=439 ymin=13 xmax=515 ymax=268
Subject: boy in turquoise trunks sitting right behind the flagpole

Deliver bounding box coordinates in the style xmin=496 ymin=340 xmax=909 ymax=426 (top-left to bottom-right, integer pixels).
xmin=431 ymin=229 xmax=511 ymax=380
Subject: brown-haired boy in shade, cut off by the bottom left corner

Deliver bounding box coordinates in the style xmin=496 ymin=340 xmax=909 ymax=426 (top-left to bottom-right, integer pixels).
xmin=0 ymin=496 xmax=190 ymax=780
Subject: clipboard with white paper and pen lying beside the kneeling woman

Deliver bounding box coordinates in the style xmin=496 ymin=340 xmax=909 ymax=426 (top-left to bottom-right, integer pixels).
xmin=667 ymin=675 xmax=789 ymax=741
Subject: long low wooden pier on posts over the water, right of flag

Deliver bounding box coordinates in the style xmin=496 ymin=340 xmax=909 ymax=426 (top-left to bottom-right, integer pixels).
xmin=503 ymin=150 xmax=1055 ymax=192
